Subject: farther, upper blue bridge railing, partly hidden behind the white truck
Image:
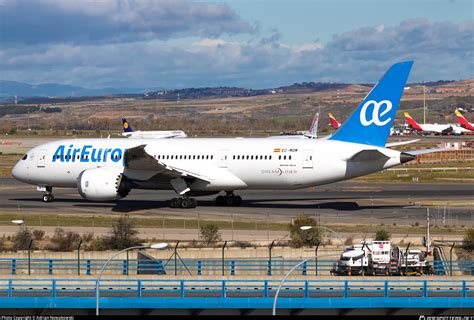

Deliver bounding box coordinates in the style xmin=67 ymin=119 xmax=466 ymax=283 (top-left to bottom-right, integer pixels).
xmin=0 ymin=258 xmax=474 ymax=276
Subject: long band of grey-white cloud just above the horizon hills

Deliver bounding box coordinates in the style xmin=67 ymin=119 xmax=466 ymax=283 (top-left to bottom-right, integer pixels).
xmin=0 ymin=19 xmax=474 ymax=88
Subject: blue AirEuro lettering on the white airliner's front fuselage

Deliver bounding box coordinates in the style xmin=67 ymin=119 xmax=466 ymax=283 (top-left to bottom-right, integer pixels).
xmin=53 ymin=144 xmax=123 ymax=162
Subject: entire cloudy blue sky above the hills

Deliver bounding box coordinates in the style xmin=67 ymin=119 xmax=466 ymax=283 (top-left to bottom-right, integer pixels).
xmin=0 ymin=0 xmax=474 ymax=89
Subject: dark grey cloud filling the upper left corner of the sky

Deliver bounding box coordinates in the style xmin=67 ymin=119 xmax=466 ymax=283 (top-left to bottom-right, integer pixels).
xmin=0 ymin=0 xmax=256 ymax=46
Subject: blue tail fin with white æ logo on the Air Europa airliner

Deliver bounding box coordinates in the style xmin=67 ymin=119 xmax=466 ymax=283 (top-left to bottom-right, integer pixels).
xmin=329 ymin=61 xmax=413 ymax=147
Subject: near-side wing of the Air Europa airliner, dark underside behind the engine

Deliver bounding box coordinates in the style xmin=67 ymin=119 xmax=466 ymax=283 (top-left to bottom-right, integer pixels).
xmin=124 ymin=145 xmax=210 ymax=182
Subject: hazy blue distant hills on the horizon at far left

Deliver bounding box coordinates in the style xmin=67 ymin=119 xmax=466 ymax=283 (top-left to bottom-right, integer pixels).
xmin=0 ymin=80 xmax=150 ymax=99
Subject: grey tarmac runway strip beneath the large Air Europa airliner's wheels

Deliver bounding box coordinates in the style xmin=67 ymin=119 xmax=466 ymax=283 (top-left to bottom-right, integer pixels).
xmin=0 ymin=178 xmax=474 ymax=226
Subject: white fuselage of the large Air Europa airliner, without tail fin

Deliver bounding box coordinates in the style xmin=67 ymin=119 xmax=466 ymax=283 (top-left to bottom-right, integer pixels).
xmin=12 ymin=138 xmax=400 ymax=191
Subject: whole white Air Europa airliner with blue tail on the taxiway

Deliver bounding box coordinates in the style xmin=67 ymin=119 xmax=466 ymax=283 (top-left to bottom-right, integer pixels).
xmin=12 ymin=61 xmax=431 ymax=208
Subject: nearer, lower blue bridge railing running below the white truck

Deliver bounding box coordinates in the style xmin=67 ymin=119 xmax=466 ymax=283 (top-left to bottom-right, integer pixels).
xmin=0 ymin=279 xmax=474 ymax=298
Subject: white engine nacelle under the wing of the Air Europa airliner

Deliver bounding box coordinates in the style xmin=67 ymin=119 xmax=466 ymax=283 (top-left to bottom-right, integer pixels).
xmin=77 ymin=167 xmax=130 ymax=201
